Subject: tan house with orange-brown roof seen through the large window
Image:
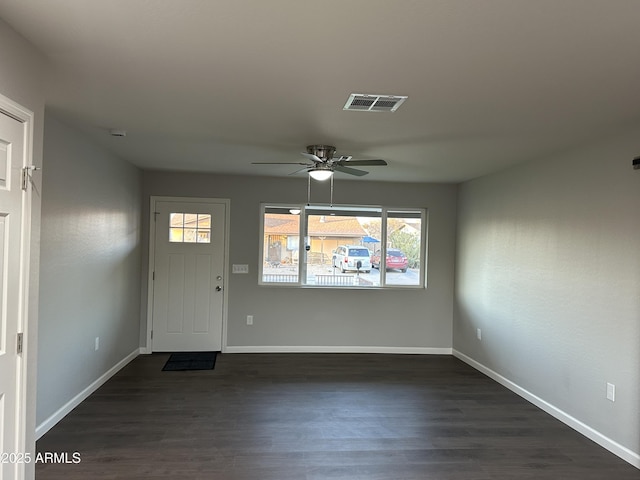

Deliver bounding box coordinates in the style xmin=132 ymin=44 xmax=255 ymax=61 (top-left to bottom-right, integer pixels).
xmin=264 ymin=214 xmax=367 ymax=265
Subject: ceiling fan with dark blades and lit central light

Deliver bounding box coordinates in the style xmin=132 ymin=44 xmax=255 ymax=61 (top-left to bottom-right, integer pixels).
xmin=252 ymin=145 xmax=387 ymax=180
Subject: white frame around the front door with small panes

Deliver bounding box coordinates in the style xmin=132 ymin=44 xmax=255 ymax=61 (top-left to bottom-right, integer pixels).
xmin=145 ymin=195 xmax=231 ymax=353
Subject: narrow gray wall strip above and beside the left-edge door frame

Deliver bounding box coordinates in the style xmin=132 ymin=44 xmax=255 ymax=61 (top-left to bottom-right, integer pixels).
xmin=0 ymin=20 xmax=45 ymax=478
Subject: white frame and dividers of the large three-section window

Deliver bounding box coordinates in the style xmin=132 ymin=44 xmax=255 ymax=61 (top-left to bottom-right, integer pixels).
xmin=258 ymin=202 xmax=428 ymax=290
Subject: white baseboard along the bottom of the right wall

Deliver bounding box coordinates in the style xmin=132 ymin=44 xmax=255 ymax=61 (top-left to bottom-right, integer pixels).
xmin=453 ymin=350 xmax=640 ymax=468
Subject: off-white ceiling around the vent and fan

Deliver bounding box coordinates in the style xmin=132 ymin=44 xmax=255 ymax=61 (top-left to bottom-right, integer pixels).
xmin=0 ymin=0 xmax=640 ymax=182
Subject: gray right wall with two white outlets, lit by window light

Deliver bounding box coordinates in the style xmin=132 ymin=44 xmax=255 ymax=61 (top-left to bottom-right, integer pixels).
xmin=454 ymin=128 xmax=640 ymax=456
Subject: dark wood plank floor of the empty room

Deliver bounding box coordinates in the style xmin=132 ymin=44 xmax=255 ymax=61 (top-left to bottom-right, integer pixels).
xmin=36 ymin=354 xmax=640 ymax=480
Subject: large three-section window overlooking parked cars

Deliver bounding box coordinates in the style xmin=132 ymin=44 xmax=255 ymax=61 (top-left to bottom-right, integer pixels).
xmin=260 ymin=204 xmax=426 ymax=288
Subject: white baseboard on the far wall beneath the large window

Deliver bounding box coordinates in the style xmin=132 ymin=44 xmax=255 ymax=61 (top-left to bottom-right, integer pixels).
xmin=223 ymin=345 xmax=452 ymax=355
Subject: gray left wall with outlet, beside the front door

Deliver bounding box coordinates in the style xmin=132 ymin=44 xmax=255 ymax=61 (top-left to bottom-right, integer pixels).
xmin=37 ymin=114 xmax=141 ymax=424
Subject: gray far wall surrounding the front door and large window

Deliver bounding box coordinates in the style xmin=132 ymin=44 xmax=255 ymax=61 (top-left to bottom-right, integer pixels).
xmin=142 ymin=172 xmax=456 ymax=349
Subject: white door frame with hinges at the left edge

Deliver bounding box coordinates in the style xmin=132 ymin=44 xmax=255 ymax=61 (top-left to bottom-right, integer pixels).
xmin=0 ymin=94 xmax=37 ymax=478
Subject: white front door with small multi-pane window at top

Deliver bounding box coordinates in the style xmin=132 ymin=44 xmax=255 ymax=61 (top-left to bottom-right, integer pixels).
xmin=152 ymin=199 xmax=227 ymax=352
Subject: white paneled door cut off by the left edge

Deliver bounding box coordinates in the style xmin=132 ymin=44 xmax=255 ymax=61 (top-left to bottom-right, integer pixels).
xmin=0 ymin=109 xmax=24 ymax=479
